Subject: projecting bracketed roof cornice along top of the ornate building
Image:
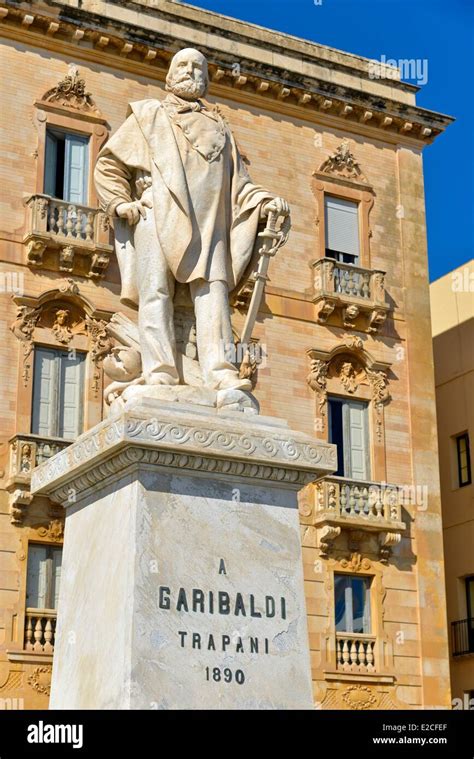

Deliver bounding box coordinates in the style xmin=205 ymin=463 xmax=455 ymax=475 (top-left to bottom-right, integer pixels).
xmin=0 ymin=0 xmax=453 ymax=148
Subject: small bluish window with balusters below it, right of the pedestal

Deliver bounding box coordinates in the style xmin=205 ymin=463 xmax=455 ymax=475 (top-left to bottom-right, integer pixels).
xmin=334 ymin=574 xmax=371 ymax=634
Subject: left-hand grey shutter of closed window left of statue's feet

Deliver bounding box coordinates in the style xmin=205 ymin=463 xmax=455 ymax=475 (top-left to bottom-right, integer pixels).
xmin=31 ymin=348 xmax=56 ymax=437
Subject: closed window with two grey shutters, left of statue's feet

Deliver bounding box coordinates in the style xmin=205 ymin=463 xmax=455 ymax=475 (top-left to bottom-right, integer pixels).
xmin=31 ymin=347 xmax=86 ymax=440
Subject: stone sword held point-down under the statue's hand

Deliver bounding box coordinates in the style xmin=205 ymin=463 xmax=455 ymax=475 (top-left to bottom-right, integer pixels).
xmin=240 ymin=211 xmax=291 ymax=351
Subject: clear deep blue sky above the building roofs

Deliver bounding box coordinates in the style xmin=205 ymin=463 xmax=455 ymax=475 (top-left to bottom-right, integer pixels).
xmin=193 ymin=0 xmax=474 ymax=280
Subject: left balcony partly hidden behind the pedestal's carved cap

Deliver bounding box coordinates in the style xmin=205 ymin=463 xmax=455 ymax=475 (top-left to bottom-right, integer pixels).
xmin=6 ymin=434 xmax=72 ymax=525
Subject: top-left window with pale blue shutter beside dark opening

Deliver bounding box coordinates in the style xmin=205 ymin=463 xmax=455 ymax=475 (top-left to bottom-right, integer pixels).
xmin=44 ymin=129 xmax=89 ymax=205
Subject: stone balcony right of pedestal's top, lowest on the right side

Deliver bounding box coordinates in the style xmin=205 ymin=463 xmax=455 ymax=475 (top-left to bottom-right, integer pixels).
xmin=306 ymin=477 xmax=406 ymax=561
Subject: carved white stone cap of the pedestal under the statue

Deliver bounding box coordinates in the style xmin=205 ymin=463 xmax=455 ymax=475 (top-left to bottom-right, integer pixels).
xmin=31 ymin=404 xmax=336 ymax=502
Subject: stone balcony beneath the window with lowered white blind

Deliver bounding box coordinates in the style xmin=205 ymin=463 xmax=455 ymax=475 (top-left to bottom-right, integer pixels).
xmin=312 ymin=257 xmax=390 ymax=332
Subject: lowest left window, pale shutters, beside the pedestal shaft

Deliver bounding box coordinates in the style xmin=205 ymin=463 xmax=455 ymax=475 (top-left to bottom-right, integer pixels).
xmin=26 ymin=544 xmax=62 ymax=609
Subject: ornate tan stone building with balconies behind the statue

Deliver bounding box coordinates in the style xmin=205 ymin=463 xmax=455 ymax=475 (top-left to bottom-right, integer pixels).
xmin=0 ymin=0 xmax=451 ymax=709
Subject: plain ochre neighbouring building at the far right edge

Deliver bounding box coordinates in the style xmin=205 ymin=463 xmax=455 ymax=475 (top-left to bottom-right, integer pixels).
xmin=430 ymin=261 xmax=474 ymax=709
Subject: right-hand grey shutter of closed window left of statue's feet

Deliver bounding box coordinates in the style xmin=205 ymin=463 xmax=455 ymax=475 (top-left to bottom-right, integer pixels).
xmin=58 ymin=352 xmax=85 ymax=440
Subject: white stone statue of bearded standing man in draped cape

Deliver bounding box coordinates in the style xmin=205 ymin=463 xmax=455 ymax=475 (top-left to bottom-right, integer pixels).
xmin=94 ymin=49 xmax=289 ymax=407
